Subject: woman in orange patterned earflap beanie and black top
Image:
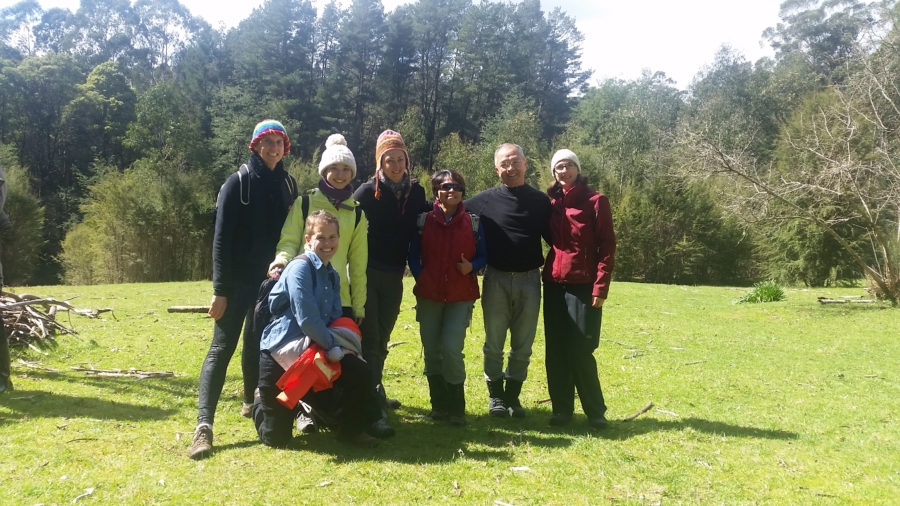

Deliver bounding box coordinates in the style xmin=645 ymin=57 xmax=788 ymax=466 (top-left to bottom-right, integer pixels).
xmin=353 ymin=130 xmax=431 ymax=416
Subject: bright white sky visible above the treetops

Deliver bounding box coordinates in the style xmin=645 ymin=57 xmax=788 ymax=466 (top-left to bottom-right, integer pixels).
xmin=14 ymin=0 xmax=783 ymax=88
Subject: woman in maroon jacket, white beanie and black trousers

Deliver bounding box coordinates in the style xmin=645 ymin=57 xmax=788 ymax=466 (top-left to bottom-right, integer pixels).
xmin=543 ymin=149 xmax=616 ymax=429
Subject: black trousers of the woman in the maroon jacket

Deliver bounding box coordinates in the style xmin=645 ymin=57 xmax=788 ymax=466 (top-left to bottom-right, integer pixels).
xmin=544 ymin=281 xmax=606 ymax=418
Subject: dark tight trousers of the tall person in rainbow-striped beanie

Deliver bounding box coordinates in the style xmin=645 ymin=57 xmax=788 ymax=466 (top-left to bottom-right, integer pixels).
xmin=197 ymin=283 xmax=259 ymax=424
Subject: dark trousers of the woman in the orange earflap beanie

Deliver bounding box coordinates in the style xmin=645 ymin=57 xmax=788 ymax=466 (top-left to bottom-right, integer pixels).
xmin=360 ymin=267 xmax=403 ymax=385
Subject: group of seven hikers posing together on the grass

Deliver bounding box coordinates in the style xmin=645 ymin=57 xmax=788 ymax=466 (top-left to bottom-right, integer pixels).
xmin=189 ymin=120 xmax=615 ymax=459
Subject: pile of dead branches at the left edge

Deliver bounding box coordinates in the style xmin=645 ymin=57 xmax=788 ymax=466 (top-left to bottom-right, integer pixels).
xmin=0 ymin=292 xmax=115 ymax=351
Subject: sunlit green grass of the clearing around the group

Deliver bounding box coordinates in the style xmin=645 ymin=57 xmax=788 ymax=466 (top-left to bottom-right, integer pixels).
xmin=0 ymin=283 xmax=900 ymax=506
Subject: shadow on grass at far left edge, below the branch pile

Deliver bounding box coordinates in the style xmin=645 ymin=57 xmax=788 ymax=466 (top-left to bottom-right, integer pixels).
xmin=0 ymin=389 xmax=176 ymax=425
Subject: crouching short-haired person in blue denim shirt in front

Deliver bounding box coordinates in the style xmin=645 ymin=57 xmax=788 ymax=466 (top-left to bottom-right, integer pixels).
xmin=253 ymin=210 xmax=394 ymax=448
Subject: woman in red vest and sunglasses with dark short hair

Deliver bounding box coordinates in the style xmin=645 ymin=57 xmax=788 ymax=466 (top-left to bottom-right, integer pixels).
xmin=409 ymin=170 xmax=487 ymax=425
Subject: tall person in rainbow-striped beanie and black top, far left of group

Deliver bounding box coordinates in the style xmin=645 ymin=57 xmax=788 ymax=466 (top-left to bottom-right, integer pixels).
xmin=188 ymin=119 xmax=297 ymax=459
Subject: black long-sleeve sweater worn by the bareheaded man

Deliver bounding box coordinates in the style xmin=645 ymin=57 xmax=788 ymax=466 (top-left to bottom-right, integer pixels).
xmin=464 ymin=184 xmax=551 ymax=272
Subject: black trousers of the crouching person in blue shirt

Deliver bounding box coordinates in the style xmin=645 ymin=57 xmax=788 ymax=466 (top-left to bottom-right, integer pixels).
xmin=252 ymin=350 xmax=381 ymax=448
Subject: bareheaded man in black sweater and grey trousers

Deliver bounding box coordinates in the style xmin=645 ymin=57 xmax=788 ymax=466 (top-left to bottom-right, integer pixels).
xmin=465 ymin=144 xmax=550 ymax=418
